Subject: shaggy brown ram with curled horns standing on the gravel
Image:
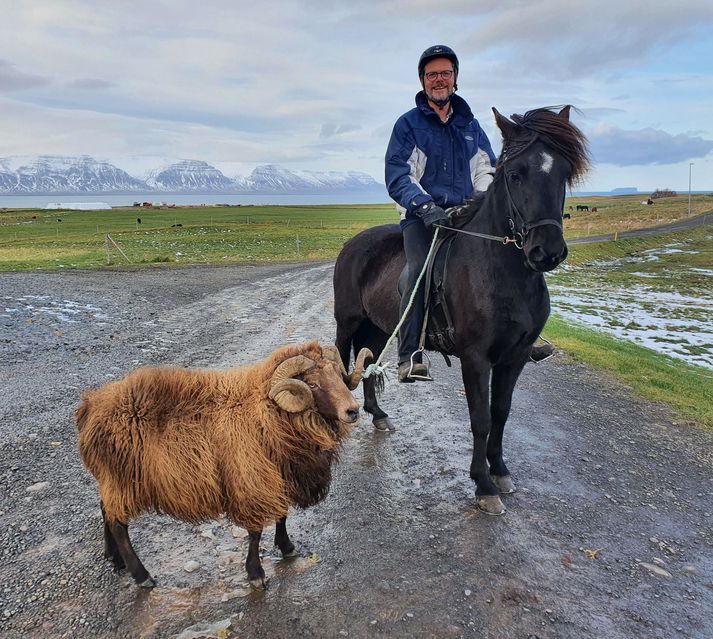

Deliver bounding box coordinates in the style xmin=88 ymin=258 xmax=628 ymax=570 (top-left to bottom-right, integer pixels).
xmin=76 ymin=342 xmax=371 ymax=587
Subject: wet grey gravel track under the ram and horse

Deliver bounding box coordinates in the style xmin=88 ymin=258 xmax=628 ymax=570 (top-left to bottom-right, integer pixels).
xmin=0 ymin=264 xmax=713 ymax=639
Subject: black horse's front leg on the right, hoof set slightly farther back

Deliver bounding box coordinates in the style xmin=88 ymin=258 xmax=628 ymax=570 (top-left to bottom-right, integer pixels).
xmin=487 ymin=364 xmax=524 ymax=494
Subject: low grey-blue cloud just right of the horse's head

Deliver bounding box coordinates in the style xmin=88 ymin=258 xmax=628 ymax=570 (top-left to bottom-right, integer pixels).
xmin=589 ymin=126 xmax=713 ymax=166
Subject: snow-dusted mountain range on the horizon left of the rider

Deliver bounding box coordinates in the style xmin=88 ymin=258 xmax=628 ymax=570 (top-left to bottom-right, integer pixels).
xmin=0 ymin=155 xmax=384 ymax=195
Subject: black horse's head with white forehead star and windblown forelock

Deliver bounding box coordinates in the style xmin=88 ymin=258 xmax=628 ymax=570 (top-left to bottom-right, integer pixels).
xmin=493 ymin=106 xmax=589 ymax=272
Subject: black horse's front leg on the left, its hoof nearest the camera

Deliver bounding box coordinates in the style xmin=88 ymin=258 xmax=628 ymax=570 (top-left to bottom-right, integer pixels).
xmin=461 ymin=355 xmax=505 ymax=515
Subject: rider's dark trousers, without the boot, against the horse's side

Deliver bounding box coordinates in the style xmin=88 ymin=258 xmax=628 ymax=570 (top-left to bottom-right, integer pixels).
xmin=399 ymin=219 xmax=433 ymax=364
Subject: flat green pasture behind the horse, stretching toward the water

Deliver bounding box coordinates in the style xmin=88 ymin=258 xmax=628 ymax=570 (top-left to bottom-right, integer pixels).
xmin=0 ymin=195 xmax=713 ymax=271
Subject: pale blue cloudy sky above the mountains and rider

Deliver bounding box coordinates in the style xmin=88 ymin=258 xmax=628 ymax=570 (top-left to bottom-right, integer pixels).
xmin=0 ymin=0 xmax=713 ymax=191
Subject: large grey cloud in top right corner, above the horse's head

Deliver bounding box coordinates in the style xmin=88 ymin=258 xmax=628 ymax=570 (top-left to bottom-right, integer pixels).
xmin=458 ymin=0 xmax=713 ymax=79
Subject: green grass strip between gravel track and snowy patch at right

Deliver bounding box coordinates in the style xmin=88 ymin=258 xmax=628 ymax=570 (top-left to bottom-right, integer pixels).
xmin=543 ymin=315 xmax=713 ymax=431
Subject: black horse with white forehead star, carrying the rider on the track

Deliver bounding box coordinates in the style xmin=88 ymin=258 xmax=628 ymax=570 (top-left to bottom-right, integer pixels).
xmin=334 ymin=106 xmax=589 ymax=514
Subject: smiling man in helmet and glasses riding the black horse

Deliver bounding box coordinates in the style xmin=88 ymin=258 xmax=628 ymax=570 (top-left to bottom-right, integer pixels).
xmin=386 ymin=44 xmax=496 ymax=382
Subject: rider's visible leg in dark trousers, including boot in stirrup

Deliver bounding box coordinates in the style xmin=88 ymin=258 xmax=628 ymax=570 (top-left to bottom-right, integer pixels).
xmin=399 ymin=220 xmax=432 ymax=383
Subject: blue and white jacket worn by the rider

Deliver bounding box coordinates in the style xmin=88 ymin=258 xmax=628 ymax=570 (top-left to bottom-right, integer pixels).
xmin=386 ymin=91 xmax=496 ymax=227
